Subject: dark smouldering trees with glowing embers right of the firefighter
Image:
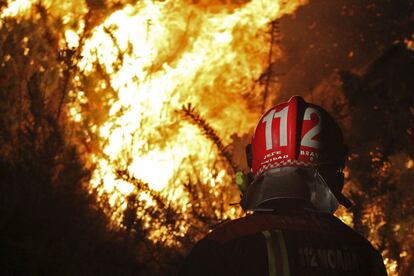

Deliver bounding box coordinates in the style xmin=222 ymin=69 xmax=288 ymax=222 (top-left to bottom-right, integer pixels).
xmin=311 ymin=44 xmax=414 ymax=275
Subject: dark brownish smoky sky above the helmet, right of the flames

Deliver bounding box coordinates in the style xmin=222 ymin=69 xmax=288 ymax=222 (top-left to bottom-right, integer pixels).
xmin=272 ymin=0 xmax=414 ymax=100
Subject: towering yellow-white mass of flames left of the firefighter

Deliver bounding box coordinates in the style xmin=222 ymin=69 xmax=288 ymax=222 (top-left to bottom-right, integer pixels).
xmin=73 ymin=1 xmax=308 ymax=238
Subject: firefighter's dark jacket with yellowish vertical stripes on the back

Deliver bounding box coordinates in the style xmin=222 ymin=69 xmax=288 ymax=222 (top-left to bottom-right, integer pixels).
xmin=179 ymin=211 xmax=387 ymax=276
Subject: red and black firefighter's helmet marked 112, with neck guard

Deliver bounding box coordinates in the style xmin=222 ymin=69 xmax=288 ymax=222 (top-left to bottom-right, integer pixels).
xmin=242 ymin=96 xmax=351 ymax=211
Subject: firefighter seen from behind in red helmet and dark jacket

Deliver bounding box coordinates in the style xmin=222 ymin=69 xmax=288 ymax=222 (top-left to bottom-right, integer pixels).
xmin=179 ymin=96 xmax=387 ymax=276
